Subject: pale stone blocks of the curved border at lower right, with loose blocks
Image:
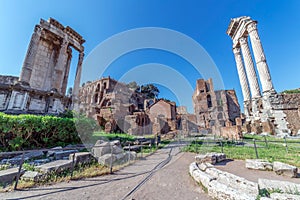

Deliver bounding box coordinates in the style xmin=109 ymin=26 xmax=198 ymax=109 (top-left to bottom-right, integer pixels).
xmin=189 ymin=153 xmax=300 ymax=200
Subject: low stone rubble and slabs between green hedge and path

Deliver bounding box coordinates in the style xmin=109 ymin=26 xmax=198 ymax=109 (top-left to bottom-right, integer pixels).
xmin=0 ymin=147 xmax=93 ymax=184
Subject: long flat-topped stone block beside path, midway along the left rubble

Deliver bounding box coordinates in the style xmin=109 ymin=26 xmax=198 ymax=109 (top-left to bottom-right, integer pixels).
xmin=36 ymin=160 xmax=72 ymax=174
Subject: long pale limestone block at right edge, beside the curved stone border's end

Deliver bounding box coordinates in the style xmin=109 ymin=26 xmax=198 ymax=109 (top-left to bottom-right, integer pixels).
xmin=258 ymin=179 xmax=300 ymax=194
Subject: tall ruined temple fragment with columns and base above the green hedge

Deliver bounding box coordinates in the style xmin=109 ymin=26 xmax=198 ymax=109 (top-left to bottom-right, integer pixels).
xmin=0 ymin=18 xmax=85 ymax=114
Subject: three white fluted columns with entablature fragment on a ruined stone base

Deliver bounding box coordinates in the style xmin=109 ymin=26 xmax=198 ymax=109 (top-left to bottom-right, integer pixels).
xmin=227 ymin=16 xmax=300 ymax=135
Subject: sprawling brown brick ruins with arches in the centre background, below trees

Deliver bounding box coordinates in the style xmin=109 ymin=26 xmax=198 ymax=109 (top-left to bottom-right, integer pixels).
xmin=79 ymin=77 xmax=177 ymax=135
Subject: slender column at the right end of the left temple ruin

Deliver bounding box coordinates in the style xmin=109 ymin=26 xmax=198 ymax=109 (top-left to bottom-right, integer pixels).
xmin=72 ymin=52 xmax=84 ymax=110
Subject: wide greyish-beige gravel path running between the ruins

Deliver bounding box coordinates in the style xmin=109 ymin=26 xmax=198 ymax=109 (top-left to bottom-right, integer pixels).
xmin=0 ymin=144 xmax=210 ymax=200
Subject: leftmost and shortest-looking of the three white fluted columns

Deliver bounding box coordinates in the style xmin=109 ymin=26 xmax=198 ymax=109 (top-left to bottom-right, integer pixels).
xmin=233 ymin=47 xmax=250 ymax=101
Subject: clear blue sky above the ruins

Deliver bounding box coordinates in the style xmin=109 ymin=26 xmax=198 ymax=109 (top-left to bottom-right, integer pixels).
xmin=0 ymin=0 xmax=300 ymax=111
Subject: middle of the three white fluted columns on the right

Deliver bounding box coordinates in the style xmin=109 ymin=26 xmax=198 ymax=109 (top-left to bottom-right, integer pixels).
xmin=239 ymin=37 xmax=261 ymax=98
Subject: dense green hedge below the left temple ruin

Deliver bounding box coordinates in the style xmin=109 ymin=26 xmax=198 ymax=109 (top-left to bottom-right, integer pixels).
xmin=0 ymin=113 xmax=95 ymax=150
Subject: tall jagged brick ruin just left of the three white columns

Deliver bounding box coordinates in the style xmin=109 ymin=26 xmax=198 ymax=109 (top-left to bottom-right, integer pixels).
xmin=193 ymin=79 xmax=241 ymax=138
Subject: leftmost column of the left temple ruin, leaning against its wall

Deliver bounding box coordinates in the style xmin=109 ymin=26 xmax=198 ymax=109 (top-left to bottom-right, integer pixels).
xmin=19 ymin=26 xmax=41 ymax=83
